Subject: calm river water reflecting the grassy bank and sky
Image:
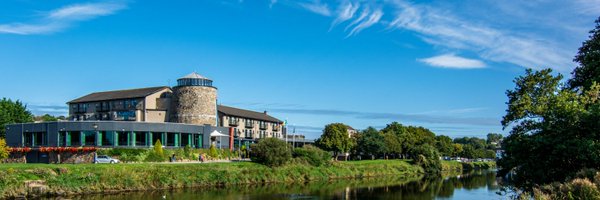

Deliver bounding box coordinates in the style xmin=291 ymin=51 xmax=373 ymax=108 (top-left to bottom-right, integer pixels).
xmin=59 ymin=171 xmax=505 ymax=200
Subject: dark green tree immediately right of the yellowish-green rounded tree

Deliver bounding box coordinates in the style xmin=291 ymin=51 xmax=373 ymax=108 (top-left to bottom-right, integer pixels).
xmin=356 ymin=127 xmax=385 ymax=158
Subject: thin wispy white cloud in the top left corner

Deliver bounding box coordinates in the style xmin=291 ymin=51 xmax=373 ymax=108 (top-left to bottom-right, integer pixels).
xmin=0 ymin=2 xmax=126 ymax=35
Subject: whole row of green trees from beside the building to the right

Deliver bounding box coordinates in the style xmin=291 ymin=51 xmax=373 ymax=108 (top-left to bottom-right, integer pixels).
xmin=315 ymin=122 xmax=503 ymax=159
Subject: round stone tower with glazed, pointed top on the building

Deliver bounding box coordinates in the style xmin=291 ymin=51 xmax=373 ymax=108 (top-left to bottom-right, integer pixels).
xmin=171 ymin=72 xmax=217 ymax=126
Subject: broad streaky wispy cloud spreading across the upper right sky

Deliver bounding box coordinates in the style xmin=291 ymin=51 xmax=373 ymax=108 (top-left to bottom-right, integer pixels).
xmin=278 ymin=0 xmax=600 ymax=73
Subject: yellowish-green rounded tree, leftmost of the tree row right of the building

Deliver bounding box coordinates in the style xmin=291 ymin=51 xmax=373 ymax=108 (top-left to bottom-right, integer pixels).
xmin=315 ymin=123 xmax=353 ymax=158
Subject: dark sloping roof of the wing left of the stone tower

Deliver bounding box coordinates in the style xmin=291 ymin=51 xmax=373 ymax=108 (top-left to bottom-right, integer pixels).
xmin=68 ymin=86 xmax=169 ymax=103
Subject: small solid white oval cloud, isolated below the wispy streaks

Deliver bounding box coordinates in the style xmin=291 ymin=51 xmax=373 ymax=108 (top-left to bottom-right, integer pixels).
xmin=419 ymin=54 xmax=485 ymax=69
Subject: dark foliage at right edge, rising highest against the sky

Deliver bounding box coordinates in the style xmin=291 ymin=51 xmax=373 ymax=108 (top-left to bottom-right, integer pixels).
xmin=568 ymin=17 xmax=600 ymax=91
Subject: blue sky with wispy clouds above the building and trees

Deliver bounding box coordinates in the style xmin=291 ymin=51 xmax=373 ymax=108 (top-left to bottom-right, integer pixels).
xmin=0 ymin=0 xmax=600 ymax=138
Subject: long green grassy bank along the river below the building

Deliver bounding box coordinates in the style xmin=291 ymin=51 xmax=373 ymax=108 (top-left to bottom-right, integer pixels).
xmin=0 ymin=160 xmax=423 ymax=198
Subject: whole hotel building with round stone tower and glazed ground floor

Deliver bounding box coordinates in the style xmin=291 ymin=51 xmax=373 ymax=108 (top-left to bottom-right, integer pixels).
xmin=6 ymin=73 xmax=285 ymax=152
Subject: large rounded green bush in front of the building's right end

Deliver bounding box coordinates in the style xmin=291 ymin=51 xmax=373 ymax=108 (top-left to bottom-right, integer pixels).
xmin=250 ymin=138 xmax=292 ymax=167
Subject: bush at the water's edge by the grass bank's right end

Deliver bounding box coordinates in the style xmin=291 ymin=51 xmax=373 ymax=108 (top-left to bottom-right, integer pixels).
xmin=412 ymin=144 xmax=442 ymax=174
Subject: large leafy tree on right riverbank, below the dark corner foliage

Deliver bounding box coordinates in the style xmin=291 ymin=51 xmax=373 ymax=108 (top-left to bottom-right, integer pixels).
xmin=498 ymin=69 xmax=600 ymax=189
